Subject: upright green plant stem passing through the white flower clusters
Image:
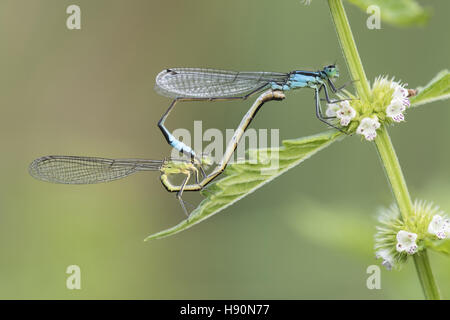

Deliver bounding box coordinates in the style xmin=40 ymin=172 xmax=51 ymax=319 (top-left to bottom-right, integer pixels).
xmin=328 ymin=0 xmax=440 ymax=299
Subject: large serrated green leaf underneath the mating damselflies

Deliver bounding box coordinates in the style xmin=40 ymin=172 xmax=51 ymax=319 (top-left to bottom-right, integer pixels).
xmin=145 ymin=130 xmax=343 ymax=240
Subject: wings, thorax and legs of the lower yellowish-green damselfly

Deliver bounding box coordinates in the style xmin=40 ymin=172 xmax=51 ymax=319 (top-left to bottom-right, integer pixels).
xmin=29 ymin=156 xmax=210 ymax=216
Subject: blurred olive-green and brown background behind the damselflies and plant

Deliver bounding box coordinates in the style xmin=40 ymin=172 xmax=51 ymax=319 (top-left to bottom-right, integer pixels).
xmin=0 ymin=0 xmax=450 ymax=299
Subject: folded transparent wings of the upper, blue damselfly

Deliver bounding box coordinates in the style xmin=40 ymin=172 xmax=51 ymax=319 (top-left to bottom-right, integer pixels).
xmin=155 ymin=68 xmax=289 ymax=98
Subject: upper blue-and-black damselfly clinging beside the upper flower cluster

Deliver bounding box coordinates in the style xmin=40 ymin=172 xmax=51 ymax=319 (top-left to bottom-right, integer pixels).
xmin=155 ymin=65 xmax=345 ymax=159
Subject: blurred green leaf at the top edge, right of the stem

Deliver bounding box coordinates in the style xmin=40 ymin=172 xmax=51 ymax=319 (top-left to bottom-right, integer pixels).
xmin=348 ymin=0 xmax=429 ymax=26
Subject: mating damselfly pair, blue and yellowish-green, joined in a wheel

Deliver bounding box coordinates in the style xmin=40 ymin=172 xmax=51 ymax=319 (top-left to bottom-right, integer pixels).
xmin=30 ymin=65 xmax=352 ymax=215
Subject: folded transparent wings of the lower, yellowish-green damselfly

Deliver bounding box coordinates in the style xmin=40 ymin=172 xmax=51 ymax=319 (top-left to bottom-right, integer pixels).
xmin=29 ymin=156 xmax=164 ymax=184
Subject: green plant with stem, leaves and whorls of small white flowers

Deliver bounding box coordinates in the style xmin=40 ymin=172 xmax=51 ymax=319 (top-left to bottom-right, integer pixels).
xmin=146 ymin=0 xmax=450 ymax=299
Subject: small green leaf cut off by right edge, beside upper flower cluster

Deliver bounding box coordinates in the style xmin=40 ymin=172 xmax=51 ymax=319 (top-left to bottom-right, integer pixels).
xmin=410 ymin=70 xmax=450 ymax=107
